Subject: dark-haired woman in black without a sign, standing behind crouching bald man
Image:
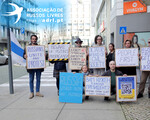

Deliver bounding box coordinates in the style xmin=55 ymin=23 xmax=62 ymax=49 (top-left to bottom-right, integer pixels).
xmin=106 ymin=43 xmax=115 ymax=70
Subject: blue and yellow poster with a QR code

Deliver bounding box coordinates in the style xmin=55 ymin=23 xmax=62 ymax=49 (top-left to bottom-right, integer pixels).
xmin=116 ymin=76 xmax=137 ymax=102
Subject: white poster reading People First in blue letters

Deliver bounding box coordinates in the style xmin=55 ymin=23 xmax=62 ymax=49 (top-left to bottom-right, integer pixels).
xmin=115 ymin=48 xmax=139 ymax=67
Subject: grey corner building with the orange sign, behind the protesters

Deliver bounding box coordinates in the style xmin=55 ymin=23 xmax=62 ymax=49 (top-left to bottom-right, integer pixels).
xmin=91 ymin=0 xmax=150 ymax=48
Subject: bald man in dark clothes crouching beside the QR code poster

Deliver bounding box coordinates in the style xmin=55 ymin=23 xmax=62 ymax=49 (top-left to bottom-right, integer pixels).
xmin=102 ymin=61 xmax=127 ymax=101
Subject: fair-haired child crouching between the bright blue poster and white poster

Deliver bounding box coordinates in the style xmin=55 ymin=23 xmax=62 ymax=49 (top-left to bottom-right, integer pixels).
xmin=81 ymin=65 xmax=90 ymax=100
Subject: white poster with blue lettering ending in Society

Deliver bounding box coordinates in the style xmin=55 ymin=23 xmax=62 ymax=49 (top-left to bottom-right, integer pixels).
xmin=89 ymin=47 xmax=106 ymax=68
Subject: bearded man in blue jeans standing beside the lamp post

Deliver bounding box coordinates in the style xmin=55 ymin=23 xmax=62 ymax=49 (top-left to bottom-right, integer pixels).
xmin=24 ymin=35 xmax=44 ymax=99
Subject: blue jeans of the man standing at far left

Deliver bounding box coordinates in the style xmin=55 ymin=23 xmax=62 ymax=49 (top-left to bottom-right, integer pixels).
xmin=29 ymin=69 xmax=41 ymax=93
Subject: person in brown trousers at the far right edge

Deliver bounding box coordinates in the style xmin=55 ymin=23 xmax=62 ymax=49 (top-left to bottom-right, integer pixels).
xmin=137 ymin=39 xmax=150 ymax=98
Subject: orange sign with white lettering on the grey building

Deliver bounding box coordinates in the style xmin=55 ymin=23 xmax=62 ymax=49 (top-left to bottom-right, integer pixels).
xmin=124 ymin=1 xmax=147 ymax=14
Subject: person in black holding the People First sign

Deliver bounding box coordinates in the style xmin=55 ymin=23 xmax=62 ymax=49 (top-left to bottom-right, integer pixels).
xmin=118 ymin=40 xmax=136 ymax=75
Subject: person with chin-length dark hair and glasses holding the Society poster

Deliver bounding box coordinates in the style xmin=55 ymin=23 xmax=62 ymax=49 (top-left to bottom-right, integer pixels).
xmin=92 ymin=35 xmax=107 ymax=75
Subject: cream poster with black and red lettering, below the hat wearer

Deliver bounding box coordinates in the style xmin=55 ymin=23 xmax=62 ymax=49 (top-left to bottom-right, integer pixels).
xmin=69 ymin=47 xmax=86 ymax=70
